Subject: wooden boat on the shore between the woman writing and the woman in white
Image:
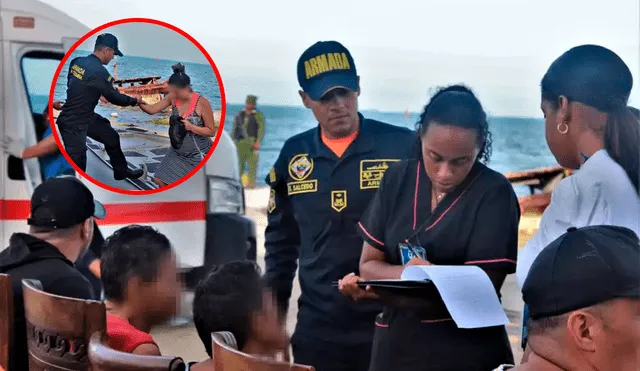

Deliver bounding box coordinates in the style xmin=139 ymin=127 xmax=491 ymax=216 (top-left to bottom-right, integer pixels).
xmin=504 ymin=166 xmax=572 ymax=214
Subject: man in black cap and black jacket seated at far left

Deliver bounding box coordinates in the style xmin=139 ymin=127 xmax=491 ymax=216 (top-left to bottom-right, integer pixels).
xmin=0 ymin=176 xmax=105 ymax=370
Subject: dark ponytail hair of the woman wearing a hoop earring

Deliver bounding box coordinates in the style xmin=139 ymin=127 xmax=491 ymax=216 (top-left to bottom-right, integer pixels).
xmin=540 ymin=45 xmax=640 ymax=194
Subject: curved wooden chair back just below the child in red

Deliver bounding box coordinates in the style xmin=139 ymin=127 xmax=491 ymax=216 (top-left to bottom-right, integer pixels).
xmin=89 ymin=332 xmax=187 ymax=371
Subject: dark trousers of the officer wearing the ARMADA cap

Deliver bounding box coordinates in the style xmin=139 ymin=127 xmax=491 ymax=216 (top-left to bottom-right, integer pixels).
xmin=292 ymin=339 xmax=372 ymax=371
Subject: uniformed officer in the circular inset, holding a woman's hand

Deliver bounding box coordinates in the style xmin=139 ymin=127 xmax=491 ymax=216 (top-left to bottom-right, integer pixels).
xmin=57 ymin=33 xmax=143 ymax=180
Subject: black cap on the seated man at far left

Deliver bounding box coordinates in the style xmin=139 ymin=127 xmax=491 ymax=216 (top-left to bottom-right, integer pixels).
xmin=27 ymin=176 xmax=106 ymax=228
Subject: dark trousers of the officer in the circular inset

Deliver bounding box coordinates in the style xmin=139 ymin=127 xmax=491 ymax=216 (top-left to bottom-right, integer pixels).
xmin=58 ymin=113 xmax=127 ymax=171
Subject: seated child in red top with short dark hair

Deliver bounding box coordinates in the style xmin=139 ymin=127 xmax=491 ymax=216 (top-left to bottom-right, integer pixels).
xmin=100 ymin=225 xmax=180 ymax=355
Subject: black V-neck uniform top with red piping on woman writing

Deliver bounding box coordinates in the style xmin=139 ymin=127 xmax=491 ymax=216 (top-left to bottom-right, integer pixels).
xmin=359 ymin=160 xmax=520 ymax=274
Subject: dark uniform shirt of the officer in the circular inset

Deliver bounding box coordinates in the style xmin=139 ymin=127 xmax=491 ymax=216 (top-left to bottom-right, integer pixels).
xmin=58 ymin=54 xmax=137 ymax=127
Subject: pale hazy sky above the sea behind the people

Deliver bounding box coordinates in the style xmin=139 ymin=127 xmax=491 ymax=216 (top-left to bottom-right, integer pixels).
xmin=44 ymin=0 xmax=640 ymax=117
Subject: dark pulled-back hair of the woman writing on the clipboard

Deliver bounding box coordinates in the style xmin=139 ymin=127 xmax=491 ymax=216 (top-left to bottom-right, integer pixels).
xmin=416 ymin=84 xmax=492 ymax=163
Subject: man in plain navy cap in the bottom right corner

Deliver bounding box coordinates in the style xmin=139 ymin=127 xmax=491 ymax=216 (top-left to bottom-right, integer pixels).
xmin=502 ymin=226 xmax=640 ymax=371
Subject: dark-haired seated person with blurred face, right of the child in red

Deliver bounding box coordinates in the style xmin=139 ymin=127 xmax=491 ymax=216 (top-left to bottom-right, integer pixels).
xmin=190 ymin=261 xmax=289 ymax=371
